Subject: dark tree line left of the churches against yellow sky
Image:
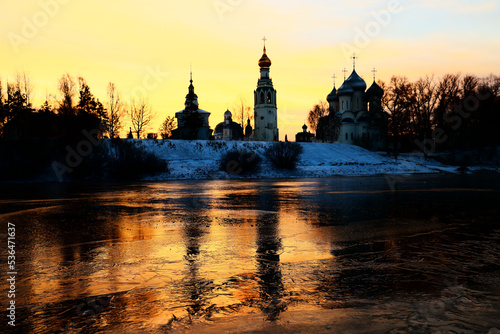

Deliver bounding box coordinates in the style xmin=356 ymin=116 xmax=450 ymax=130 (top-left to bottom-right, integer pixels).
xmin=0 ymin=73 xmax=175 ymax=138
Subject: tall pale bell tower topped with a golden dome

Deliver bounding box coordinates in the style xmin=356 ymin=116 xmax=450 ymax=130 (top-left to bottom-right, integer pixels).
xmin=254 ymin=37 xmax=279 ymax=141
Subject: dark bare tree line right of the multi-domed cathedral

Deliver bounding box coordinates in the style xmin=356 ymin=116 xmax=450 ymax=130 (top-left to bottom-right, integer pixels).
xmin=379 ymin=74 xmax=500 ymax=153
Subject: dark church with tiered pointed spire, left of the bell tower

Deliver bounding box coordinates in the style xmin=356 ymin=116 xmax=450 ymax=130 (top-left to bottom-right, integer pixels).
xmin=171 ymin=74 xmax=212 ymax=140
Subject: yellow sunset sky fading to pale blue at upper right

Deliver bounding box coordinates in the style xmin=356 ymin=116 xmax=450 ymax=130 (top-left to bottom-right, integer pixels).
xmin=0 ymin=0 xmax=500 ymax=139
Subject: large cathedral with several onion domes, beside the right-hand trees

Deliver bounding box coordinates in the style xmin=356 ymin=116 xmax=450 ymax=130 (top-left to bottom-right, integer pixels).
xmin=327 ymin=57 xmax=387 ymax=150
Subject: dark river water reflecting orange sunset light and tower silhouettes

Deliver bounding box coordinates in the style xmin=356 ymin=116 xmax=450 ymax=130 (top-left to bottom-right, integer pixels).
xmin=0 ymin=174 xmax=500 ymax=333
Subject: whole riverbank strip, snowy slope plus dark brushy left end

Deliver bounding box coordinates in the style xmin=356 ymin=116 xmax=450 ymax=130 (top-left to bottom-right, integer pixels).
xmin=0 ymin=139 xmax=500 ymax=183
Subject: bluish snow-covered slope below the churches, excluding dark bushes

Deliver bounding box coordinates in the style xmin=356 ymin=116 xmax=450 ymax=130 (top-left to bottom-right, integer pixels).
xmin=137 ymin=140 xmax=472 ymax=180
